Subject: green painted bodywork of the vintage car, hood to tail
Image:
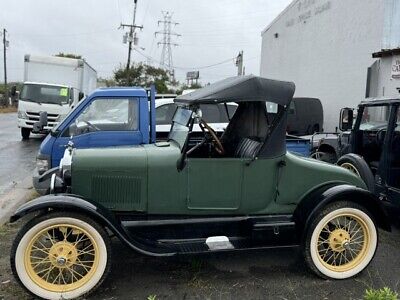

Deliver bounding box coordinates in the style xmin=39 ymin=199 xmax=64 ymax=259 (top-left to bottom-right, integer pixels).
xmin=72 ymin=142 xmax=366 ymax=215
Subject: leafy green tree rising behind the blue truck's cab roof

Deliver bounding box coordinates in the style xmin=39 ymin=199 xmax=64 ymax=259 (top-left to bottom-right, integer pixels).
xmin=114 ymin=63 xmax=176 ymax=94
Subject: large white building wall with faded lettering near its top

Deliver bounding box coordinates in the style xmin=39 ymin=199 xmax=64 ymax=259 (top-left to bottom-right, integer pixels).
xmin=260 ymin=0 xmax=384 ymax=131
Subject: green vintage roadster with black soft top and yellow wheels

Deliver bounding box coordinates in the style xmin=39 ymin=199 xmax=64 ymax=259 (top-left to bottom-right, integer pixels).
xmin=11 ymin=76 xmax=390 ymax=299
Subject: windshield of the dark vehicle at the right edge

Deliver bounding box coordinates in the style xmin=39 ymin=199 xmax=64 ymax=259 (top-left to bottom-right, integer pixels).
xmin=360 ymin=106 xmax=389 ymax=130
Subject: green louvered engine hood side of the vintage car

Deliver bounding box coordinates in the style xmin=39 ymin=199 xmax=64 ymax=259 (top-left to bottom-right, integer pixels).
xmin=72 ymin=146 xmax=147 ymax=211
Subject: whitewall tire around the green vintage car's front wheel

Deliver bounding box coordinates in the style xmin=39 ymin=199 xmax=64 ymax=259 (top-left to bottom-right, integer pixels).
xmin=10 ymin=212 xmax=111 ymax=299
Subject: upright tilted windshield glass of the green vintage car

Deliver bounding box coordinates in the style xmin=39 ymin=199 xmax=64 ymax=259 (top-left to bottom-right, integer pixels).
xmin=168 ymin=107 xmax=193 ymax=149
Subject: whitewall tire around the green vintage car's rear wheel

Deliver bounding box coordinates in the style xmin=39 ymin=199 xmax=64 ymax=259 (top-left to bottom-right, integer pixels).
xmin=303 ymin=201 xmax=378 ymax=279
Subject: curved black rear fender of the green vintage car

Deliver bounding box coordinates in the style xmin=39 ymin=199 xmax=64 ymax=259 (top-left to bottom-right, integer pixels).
xmin=293 ymin=184 xmax=391 ymax=236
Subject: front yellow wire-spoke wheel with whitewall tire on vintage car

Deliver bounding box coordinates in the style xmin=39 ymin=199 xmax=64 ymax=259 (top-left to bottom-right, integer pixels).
xmin=11 ymin=212 xmax=111 ymax=299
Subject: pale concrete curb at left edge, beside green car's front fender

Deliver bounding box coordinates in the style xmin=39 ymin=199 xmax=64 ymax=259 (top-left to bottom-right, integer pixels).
xmin=0 ymin=176 xmax=36 ymax=225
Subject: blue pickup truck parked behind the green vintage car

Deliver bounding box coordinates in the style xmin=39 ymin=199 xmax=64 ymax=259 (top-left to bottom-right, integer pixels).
xmin=33 ymin=88 xmax=309 ymax=194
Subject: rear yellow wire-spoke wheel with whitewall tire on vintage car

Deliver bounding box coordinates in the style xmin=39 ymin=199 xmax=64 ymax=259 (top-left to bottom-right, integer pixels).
xmin=303 ymin=201 xmax=378 ymax=279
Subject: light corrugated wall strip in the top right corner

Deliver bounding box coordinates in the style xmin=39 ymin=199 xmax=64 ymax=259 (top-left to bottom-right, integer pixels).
xmin=382 ymin=0 xmax=400 ymax=49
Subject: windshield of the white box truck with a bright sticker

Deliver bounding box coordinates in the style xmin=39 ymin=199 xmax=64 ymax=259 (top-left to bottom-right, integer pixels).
xmin=20 ymin=84 xmax=69 ymax=105
